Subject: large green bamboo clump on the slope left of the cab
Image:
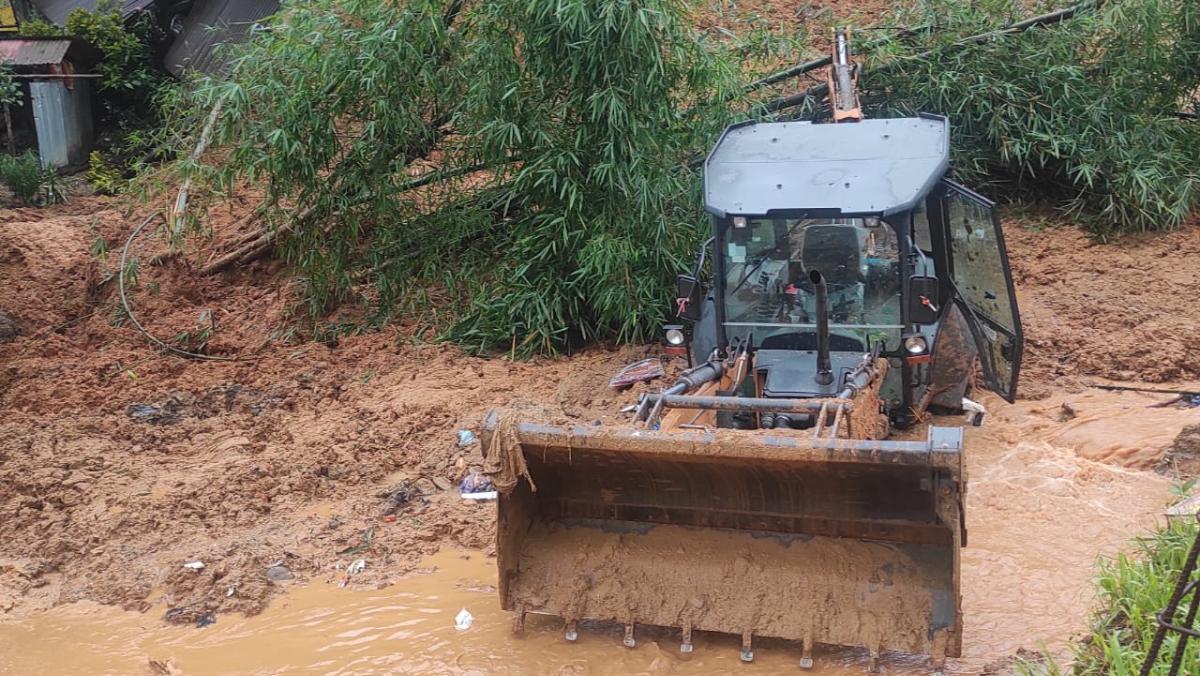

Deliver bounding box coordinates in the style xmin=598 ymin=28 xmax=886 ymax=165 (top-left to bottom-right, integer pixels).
xmin=168 ymin=0 xmax=736 ymax=354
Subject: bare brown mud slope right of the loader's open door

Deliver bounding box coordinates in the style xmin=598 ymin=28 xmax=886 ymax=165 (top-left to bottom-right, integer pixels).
xmin=1006 ymin=223 xmax=1200 ymax=396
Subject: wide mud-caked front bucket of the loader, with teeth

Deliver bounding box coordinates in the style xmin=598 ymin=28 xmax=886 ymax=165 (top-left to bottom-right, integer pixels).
xmin=482 ymin=414 xmax=965 ymax=664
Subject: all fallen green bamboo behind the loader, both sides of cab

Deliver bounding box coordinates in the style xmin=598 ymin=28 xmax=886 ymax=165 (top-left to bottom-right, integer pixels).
xmin=159 ymin=0 xmax=1200 ymax=354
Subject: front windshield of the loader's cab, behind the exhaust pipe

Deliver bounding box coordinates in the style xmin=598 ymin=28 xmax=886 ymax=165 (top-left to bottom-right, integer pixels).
xmin=720 ymin=219 xmax=902 ymax=349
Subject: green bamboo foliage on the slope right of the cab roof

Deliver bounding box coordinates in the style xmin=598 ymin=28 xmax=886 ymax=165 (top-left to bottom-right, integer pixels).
xmin=863 ymin=0 xmax=1200 ymax=237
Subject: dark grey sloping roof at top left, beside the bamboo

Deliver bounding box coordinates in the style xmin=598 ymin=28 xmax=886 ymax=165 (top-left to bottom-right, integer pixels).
xmin=166 ymin=0 xmax=280 ymax=76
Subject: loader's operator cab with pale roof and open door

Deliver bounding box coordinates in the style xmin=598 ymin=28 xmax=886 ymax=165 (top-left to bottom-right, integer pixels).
xmin=674 ymin=115 xmax=1021 ymax=425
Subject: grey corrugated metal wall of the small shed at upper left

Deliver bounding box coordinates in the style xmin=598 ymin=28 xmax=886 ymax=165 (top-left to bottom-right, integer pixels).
xmin=29 ymin=80 xmax=92 ymax=168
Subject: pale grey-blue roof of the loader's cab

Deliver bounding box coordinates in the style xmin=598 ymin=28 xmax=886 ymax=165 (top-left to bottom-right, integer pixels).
xmin=704 ymin=115 xmax=950 ymax=216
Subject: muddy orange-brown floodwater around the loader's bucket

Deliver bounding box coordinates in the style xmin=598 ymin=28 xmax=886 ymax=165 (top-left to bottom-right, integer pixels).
xmin=0 ymin=391 xmax=1180 ymax=675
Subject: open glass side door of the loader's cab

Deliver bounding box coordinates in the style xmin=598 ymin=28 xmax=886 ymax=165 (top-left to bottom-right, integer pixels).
xmin=942 ymin=180 xmax=1025 ymax=401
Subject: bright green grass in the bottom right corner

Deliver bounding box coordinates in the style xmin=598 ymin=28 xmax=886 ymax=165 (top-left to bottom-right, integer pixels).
xmin=1018 ymin=522 xmax=1200 ymax=676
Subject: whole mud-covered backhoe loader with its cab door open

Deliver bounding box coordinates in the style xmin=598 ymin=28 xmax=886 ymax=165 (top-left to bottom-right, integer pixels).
xmin=484 ymin=36 xmax=1021 ymax=670
